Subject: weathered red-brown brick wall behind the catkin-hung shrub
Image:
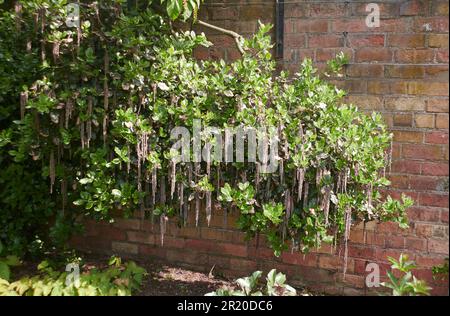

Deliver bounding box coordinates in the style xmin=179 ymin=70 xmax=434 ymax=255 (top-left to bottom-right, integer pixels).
xmin=75 ymin=0 xmax=449 ymax=295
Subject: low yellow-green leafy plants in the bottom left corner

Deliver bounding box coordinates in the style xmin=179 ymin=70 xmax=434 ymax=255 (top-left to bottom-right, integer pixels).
xmin=0 ymin=257 xmax=147 ymax=296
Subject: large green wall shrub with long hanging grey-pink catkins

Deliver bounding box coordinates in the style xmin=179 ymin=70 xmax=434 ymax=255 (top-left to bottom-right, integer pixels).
xmin=0 ymin=0 xmax=411 ymax=272
